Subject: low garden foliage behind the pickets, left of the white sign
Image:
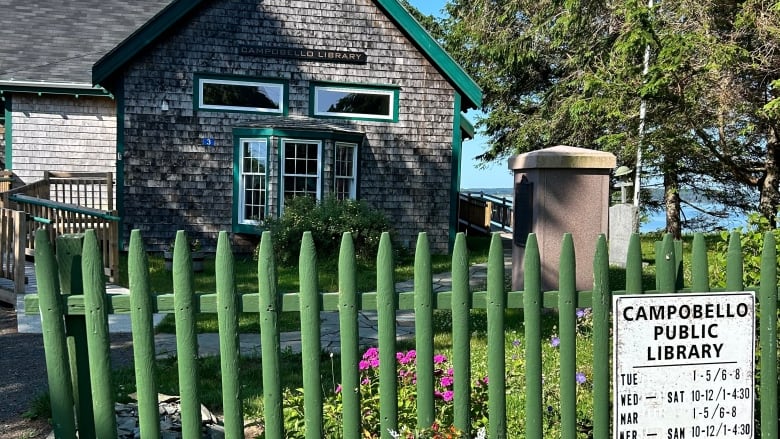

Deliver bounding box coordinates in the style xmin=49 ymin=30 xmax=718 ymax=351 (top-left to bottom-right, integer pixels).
xmin=272 ymin=309 xmax=593 ymax=439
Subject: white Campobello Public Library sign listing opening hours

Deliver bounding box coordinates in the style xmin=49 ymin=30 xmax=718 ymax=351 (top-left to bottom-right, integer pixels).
xmin=612 ymin=292 xmax=756 ymax=439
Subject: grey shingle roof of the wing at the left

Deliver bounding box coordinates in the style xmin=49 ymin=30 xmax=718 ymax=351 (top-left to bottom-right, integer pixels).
xmin=0 ymin=0 xmax=171 ymax=85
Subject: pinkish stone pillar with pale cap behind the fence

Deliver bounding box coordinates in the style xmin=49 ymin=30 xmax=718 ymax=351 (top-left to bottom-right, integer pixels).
xmin=509 ymin=146 xmax=617 ymax=290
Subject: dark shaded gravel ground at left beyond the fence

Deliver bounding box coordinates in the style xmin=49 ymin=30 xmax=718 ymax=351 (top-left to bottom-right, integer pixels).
xmin=0 ymin=303 xmax=133 ymax=439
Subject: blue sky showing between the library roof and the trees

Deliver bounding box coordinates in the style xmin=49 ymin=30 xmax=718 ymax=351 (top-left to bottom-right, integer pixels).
xmin=409 ymin=0 xmax=512 ymax=189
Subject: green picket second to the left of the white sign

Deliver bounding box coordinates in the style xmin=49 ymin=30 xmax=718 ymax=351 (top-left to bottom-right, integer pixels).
xmin=558 ymin=233 xmax=577 ymax=439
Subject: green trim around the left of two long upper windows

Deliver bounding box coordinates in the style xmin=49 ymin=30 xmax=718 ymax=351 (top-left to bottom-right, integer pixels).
xmin=192 ymin=73 xmax=290 ymax=116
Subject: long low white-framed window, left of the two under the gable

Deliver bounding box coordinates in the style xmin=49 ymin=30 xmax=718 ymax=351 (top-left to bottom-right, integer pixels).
xmin=195 ymin=76 xmax=287 ymax=114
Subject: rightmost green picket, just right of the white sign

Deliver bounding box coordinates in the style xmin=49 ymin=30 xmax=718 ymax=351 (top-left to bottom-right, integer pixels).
xmin=756 ymin=232 xmax=778 ymax=439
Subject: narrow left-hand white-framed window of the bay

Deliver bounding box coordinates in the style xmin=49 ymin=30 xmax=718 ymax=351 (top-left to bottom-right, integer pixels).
xmin=237 ymin=138 xmax=268 ymax=225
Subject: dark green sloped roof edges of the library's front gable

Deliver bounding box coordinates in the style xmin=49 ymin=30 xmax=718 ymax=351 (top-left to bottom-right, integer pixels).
xmin=91 ymin=0 xmax=482 ymax=110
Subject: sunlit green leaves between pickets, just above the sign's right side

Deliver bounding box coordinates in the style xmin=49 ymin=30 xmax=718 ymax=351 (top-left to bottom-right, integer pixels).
xmin=710 ymin=213 xmax=780 ymax=287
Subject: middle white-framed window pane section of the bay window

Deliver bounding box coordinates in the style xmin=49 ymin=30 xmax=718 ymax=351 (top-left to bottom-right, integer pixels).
xmin=281 ymin=139 xmax=322 ymax=210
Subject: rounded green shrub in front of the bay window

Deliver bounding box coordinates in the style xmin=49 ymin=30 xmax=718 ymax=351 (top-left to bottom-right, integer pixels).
xmin=264 ymin=196 xmax=391 ymax=264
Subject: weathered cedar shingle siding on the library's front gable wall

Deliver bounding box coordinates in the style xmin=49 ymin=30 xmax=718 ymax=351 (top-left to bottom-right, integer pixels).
xmin=122 ymin=0 xmax=460 ymax=251
